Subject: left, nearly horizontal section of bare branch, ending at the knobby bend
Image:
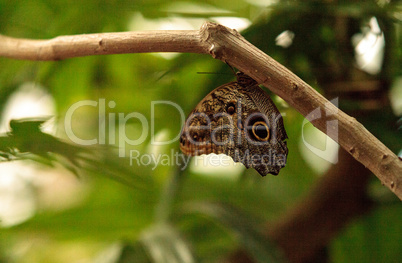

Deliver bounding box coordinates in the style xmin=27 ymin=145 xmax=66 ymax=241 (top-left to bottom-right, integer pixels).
xmin=0 ymin=30 xmax=206 ymax=60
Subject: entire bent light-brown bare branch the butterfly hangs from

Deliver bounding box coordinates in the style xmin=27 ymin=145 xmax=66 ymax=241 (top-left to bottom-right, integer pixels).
xmin=0 ymin=22 xmax=402 ymax=200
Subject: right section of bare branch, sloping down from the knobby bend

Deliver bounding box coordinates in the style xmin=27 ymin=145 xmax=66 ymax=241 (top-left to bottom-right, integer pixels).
xmin=201 ymin=23 xmax=402 ymax=200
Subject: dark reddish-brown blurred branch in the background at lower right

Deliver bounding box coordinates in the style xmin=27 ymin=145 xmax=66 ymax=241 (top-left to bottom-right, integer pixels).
xmin=225 ymin=150 xmax=374 ymax=263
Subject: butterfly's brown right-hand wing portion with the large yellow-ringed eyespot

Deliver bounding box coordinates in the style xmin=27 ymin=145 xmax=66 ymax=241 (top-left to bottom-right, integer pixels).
xmin=232 ymin=85 xmax=288 ymax=176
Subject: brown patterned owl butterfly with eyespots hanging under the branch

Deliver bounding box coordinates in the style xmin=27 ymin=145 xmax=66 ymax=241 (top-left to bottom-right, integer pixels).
xmin=180 ymin=73 xmax=288 ymax=176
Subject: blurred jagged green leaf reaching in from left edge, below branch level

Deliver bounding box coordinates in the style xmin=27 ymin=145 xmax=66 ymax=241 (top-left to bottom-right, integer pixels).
xmin=0 ymin=118 xmax=152 ymax=189
